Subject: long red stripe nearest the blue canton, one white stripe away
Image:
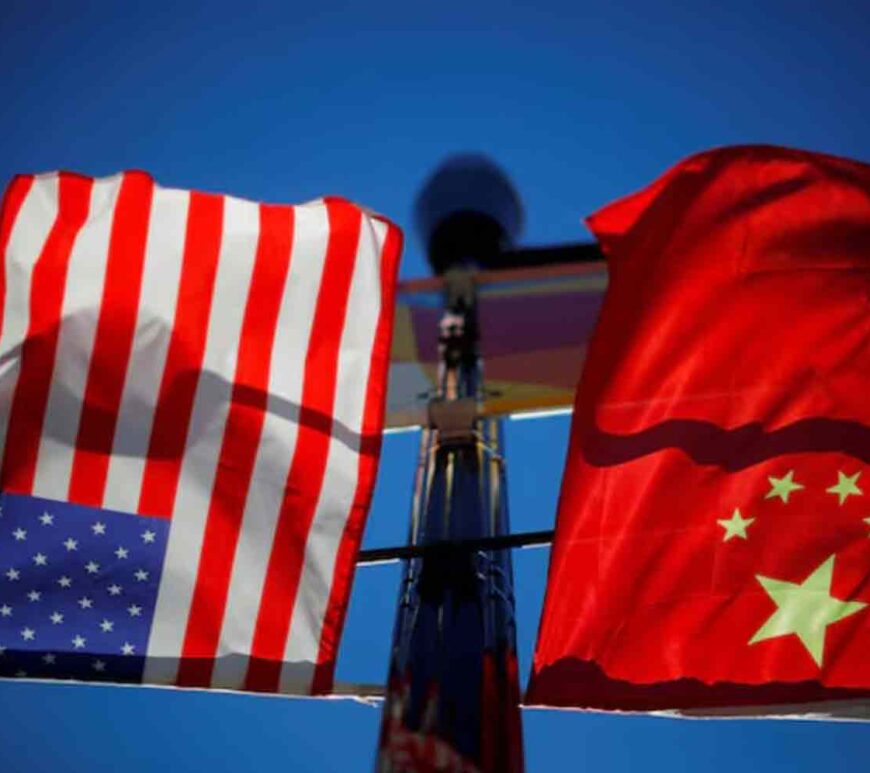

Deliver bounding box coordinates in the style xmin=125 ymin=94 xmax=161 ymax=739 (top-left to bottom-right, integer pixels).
xmin=177 ymin=205 xmax=293 ymax=687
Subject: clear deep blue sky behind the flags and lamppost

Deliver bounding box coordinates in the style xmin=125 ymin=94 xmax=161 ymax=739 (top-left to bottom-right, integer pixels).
xmin=0 ymin=0 xmax=870 ymax=773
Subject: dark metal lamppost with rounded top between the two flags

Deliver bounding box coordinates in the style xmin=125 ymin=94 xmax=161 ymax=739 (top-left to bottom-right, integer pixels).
xmin=376 ymin=156 xmax=523 ymax=772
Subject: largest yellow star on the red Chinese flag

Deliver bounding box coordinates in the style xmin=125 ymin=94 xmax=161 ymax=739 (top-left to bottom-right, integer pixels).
xmin=749 ymin=555 xmax=867 ymax=668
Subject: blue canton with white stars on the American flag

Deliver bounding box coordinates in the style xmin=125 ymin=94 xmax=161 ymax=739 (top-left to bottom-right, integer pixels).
xmin=0 ymin=493 xmax=169 ymax=682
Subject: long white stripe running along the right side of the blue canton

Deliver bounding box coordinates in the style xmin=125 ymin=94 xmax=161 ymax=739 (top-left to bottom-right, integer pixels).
xmin=143 ymin=197 xmax=260 ymax=684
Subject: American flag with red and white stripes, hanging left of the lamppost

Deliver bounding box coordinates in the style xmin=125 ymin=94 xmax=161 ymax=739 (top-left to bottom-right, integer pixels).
xmin=0 ymin=172 xmax=401 ymax=693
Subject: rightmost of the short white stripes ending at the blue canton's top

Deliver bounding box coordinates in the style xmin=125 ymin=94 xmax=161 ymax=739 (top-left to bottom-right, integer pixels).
xmin=103 ymin=186 xmax=190 ymax=513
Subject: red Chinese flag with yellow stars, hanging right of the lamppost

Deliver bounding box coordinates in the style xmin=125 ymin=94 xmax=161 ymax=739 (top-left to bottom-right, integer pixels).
xmin=526 ymin=146 xmax=870 ymax=716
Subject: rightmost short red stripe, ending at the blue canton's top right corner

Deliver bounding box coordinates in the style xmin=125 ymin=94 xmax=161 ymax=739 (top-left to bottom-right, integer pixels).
xmin=138 ymin=193 xmax=224 ymax=518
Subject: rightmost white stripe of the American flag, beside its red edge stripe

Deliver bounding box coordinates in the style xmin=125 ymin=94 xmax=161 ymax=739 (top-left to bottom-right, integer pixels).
xmin=280 ymin=218 xmax=387 ymax=692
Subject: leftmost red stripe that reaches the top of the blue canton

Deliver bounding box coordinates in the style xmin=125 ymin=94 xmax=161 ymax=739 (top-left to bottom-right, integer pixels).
xmin=0 ymin=173 xmax=93 ymax=494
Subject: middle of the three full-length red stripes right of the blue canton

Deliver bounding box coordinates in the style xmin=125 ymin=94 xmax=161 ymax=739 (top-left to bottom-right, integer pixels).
xmin=245 ymin=199 xmax=362 ymax=692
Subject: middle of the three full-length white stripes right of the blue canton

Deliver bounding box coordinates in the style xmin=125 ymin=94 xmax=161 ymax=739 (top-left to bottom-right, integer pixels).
xmin=212 ymin=202 xmax=329 ymax=688
